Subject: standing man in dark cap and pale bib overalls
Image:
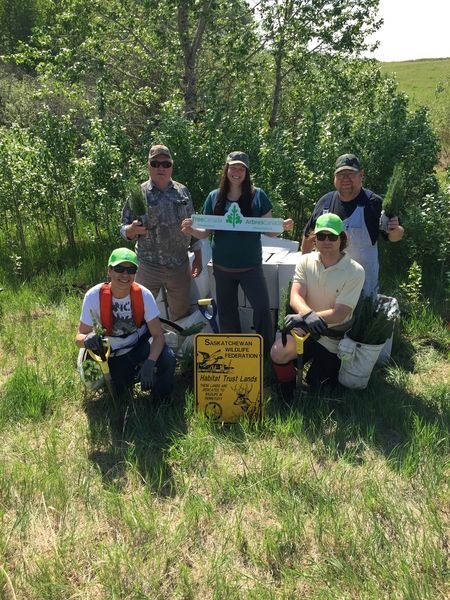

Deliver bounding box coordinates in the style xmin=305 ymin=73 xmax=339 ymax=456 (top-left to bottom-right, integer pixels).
xmin=301 ymin=154 xmax=404 ymax=296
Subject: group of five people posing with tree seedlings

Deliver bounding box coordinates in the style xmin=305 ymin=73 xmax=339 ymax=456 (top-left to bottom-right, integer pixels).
xmin=76 ymin=144 xmax=403 ymax=397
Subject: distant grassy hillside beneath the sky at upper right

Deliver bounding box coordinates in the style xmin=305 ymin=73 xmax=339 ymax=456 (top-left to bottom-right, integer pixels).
xmin=381 ymin=58 xmax=450 ymax=107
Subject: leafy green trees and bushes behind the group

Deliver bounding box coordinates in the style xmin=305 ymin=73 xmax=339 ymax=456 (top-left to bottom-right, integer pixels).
xmin=0 ymin=0 xmax=448 ymax=308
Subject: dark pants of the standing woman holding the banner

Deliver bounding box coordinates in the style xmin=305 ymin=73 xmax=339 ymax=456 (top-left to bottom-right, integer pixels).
xmin=214 ymin=265 xmax=274 ymax=353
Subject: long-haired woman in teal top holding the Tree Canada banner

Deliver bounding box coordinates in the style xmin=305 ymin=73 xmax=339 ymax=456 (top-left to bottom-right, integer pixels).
xmin=182 ymin=151 xmax=294 ymax=352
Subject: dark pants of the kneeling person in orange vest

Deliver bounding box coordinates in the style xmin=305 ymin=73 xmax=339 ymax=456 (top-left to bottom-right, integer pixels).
xmin=108 ymin=335 xmax=176 ymax=398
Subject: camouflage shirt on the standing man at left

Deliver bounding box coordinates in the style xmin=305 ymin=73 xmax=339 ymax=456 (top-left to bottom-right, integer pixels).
xmin=120 ymin=179 xmax=201 ymax=267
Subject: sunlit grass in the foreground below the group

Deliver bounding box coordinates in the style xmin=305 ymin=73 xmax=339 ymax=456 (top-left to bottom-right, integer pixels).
xmin=0 ymin=270 xmax=449 ymax=600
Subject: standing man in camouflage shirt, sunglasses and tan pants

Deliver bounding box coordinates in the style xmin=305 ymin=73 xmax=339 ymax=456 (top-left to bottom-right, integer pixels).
xmin=120 ymin=144 xmax=202 ymax=321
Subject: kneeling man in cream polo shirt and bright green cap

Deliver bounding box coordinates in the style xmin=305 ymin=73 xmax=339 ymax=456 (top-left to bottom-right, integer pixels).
xmin=270 ymin=213 xmax=364 ymax=393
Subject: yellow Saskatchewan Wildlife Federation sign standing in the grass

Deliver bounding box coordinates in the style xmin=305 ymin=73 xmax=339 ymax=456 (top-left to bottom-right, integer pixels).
xmin=194 ymin=333 xmax=263 ymax=423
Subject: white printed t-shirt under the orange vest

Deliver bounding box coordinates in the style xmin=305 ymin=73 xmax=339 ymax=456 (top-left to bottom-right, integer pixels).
xmin=80 ymin=283 xmax=160 ymax=356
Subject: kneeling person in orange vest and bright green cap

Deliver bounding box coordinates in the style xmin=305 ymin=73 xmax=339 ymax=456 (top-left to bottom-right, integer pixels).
xmin=75 ymin=248 xmax=176 ymax=398
